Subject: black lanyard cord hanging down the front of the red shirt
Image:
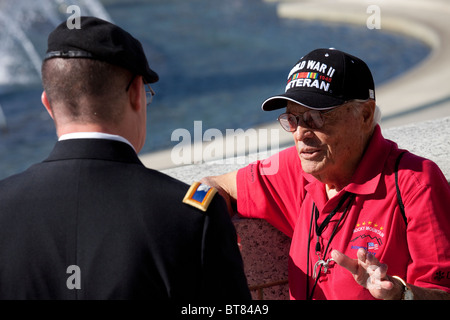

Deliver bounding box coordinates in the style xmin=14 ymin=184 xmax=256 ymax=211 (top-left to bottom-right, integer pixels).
xmin=306 ymin=192 xmax=355 ymax=300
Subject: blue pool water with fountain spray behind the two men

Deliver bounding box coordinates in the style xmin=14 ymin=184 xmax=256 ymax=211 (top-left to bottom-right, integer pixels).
xmin=0 ymin=0 xmax=429 ymax=178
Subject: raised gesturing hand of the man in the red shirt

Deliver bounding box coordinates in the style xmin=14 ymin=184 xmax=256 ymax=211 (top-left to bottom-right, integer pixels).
xmin=331 ymin=248 xmax=401 ymax=300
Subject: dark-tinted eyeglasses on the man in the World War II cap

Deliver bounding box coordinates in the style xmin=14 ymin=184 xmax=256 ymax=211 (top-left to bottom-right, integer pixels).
xmin=278 ymin=107 xmax=337 ymax=132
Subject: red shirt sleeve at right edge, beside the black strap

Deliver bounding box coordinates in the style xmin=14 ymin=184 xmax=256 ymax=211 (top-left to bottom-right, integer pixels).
xmin=400 ymin=155 xmax=450 ymax=292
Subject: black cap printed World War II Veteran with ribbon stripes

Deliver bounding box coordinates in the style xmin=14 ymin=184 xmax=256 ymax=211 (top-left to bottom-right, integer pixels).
xmin=261 ymin=48 xmax=375 ymax=111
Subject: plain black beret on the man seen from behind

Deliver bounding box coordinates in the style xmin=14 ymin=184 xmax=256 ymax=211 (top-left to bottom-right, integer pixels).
xmin=44 ymin=17 xmax=159 ymax=83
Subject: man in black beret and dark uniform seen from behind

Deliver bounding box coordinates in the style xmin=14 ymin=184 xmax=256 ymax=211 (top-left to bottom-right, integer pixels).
xmin=0 ymin=17 xmax=250 ymax=300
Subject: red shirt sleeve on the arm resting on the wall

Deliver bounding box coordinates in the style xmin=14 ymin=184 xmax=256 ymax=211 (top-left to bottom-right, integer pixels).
xmin=236 ymin=147 xmax=304 ymax=237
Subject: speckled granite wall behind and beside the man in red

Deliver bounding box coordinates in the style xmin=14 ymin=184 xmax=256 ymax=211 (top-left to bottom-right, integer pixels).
xmin=163 ymin=117 xmax=450 ymax=300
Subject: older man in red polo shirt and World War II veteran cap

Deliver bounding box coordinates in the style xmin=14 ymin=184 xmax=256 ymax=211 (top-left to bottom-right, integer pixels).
xmin=203 ymin=49 xmax=450 ymax=299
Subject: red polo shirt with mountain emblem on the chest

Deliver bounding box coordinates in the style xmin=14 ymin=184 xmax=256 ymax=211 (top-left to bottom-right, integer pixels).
xmin=237 ymin=126 xmax=450 ymax=299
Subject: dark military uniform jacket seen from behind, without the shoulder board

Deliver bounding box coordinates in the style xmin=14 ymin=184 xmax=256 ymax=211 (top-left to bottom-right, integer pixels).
xmin=0 ymin=139 xmax=250 ymax=299
